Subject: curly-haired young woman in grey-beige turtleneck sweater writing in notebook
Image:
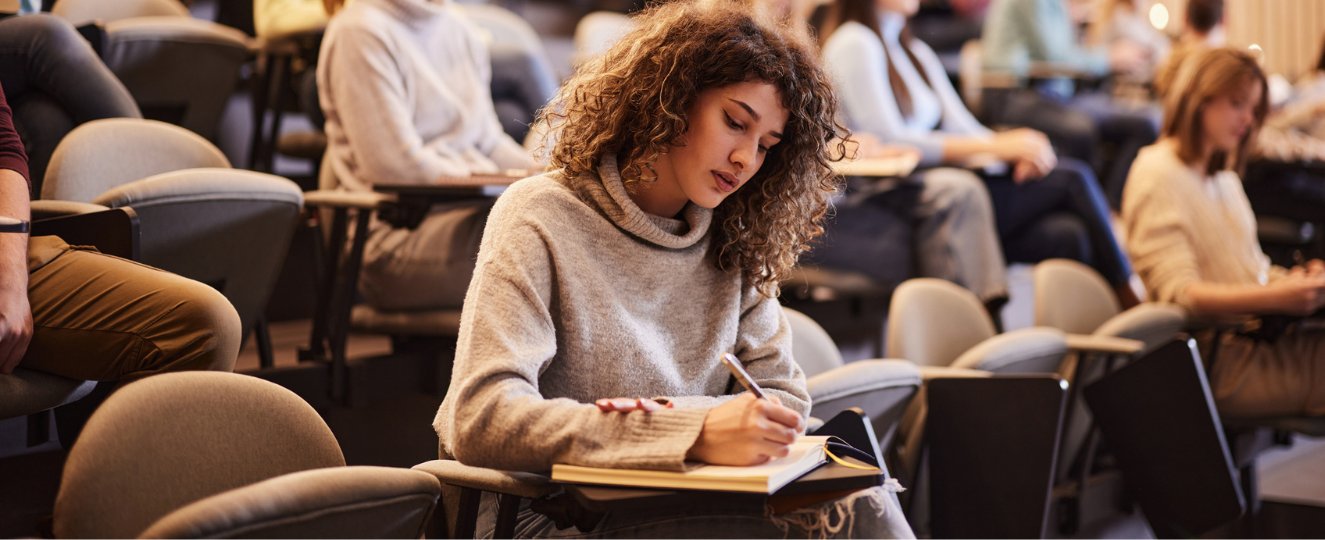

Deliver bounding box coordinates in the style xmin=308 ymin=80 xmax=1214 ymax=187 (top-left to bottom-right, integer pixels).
xmin=435 ymin=0 xmax=912 ymax=537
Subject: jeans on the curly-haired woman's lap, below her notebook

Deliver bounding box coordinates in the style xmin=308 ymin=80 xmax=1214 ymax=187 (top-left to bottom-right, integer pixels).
xmin=500 ymin=487 xmax=916 ymax=539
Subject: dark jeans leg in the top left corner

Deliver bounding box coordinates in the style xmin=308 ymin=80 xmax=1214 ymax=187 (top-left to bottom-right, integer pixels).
xmin=0 ymin=13 xmax=143 ymax=195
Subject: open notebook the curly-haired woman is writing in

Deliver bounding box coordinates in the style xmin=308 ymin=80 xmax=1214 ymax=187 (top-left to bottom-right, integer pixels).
xmin=553 ymin=437 xmax=828 ymax=494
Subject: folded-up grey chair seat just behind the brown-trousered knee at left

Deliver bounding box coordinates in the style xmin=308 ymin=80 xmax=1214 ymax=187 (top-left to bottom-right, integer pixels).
xmin=95 ymin=168 xmax=303 ymax=337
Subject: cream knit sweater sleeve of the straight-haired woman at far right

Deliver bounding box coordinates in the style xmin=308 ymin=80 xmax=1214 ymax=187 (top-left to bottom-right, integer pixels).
xmin=1122 ymin=154 xmax=1200 ymax=308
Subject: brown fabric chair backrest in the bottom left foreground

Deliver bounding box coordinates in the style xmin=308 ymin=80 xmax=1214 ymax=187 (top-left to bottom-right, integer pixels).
xmin=54 ymin=372 xmax=345 ymax=539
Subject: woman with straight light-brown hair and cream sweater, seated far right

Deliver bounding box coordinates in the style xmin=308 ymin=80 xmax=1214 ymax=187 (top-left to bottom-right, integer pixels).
xmin=1122 ymin=49 xmax=1325 ymax=416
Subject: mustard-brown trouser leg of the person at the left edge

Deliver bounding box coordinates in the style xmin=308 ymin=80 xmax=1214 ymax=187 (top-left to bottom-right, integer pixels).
xmin=19 ymin=237 xmax=242 ymax=381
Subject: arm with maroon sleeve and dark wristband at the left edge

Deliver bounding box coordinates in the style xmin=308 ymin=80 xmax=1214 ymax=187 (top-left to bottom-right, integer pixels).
xmin=0 ymin=90 xmax=32 ymax=373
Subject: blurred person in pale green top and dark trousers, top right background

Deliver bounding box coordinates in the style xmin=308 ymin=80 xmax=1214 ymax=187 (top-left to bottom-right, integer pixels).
xmin=981 ymin=0 xmax=1159 ymax=209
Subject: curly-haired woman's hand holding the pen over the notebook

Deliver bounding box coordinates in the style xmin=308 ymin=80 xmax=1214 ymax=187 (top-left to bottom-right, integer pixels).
xmin=685 ymin=392 xmax=806 ymax=466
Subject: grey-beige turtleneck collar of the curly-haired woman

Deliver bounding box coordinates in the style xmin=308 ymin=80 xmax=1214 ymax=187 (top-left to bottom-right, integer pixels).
xmin=566 ymin=155 xmax=713 ymax=249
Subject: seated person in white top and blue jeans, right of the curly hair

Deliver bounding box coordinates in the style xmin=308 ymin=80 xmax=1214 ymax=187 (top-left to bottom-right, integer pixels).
xmin=823 ymin=0 xmax=1137 ymax=306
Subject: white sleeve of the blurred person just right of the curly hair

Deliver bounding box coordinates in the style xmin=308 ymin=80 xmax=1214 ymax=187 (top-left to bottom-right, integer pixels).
xmin=823 ymin=23 xmax=943 ymax=165
